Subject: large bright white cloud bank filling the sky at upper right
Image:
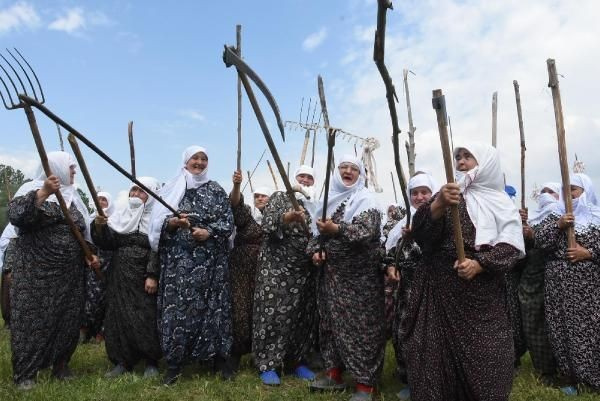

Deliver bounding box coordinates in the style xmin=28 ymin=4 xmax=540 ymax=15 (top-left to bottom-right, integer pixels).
xmin=332 ymin=0 xmax=600 ymax=209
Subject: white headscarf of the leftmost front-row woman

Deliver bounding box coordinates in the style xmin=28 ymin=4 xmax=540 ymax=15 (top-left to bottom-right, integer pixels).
xmin=14 ymin=151 xmax=92 ymax=242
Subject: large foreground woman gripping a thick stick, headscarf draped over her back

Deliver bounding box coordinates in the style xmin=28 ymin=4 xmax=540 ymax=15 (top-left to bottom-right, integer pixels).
xmin=402 ymin=144 xmax=525 ymax=401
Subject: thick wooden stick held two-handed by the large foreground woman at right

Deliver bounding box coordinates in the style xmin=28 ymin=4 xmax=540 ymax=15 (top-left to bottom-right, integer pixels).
xmin=432 ymin=89 xmax=465 ymax=262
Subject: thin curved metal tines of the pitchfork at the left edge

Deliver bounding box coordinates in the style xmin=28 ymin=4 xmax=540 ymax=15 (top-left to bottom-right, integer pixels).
xmin=0 ymin=48 xmax=46 ymax=110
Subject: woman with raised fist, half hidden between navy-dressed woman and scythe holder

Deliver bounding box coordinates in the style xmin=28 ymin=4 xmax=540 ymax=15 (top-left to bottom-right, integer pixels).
xmin=229 ymin=171 xmax=271 ymax=370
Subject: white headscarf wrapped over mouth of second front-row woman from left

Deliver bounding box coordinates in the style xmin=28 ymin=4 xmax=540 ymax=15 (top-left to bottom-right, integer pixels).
xmin=108 ymin=177 xmax=160 ymax=234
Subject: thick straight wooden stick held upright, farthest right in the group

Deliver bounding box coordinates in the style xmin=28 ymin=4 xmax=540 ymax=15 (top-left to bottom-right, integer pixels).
xmin=546 ymin=58 xmax=576 ymax=248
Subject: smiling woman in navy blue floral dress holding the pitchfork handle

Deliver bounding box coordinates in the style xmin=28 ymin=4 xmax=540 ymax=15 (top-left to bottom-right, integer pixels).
xmin=148 ymin=145 xmax=233 ymax=385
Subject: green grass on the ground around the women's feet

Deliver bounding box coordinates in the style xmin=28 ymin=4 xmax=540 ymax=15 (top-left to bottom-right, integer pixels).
xmin=0 ymin=323 xmax=600 ymax=401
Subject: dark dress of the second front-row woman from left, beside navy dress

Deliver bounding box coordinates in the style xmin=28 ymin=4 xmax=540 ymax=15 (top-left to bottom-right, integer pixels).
xmin=91 ymin=223 xmax=161 ymax=369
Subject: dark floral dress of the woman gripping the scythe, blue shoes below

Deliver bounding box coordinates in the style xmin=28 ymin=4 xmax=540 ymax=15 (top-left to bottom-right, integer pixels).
xmin=252 ymin=192 xmax=317 ymax=372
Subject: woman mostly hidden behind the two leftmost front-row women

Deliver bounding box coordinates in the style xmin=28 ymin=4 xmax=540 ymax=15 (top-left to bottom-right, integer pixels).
xmin=79 ymin=191 xmax=115 ymax=342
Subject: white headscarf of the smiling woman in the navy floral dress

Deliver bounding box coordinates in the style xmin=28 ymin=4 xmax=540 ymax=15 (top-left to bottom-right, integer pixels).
xmin=148 ymin=145 xmax=209 ymax=251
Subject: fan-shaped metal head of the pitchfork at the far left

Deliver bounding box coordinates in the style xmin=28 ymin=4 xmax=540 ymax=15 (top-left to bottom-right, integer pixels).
xmin=0 ymin=48 xmax=46 ymax=110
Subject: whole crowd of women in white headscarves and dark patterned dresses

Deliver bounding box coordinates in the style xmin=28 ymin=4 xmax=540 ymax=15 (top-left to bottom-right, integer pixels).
xmin=0 ymin=143 xmax=600 ymax=401
